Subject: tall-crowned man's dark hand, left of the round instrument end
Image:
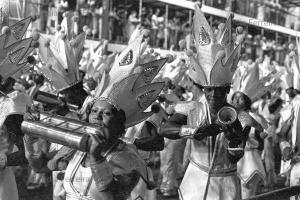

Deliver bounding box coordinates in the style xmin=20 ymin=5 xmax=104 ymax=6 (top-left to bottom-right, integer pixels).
xmin=194 ymin=124 xmax=222 ymax=140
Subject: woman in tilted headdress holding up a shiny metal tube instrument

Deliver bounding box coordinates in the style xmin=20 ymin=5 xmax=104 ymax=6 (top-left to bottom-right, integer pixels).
xmin=25 ymin=30 xmax=166 ymax=199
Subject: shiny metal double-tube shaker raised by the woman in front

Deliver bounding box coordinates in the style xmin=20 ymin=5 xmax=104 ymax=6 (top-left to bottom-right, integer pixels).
xmin=21 ymin=113 xmax=102 ymax=152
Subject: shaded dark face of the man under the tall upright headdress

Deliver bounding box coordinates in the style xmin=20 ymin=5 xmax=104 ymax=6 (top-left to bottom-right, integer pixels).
xmin=202 ymin=87 xmax=228 ymax=108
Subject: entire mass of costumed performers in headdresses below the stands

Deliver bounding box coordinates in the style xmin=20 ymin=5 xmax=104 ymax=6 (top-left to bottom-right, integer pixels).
xmin=0 ymin=4 xmax=300 ymax=200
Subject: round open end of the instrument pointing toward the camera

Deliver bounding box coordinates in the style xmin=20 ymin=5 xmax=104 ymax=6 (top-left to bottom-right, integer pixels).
xmin=218 ymin=106 xmax=238 ymax=125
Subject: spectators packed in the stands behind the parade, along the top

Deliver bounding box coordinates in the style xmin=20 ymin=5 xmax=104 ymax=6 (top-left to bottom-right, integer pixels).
xmin=21 ymin=0 xmax=297 ymax=65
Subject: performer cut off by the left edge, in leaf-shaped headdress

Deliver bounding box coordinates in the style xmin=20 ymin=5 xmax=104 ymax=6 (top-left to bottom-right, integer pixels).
xmin=0 ymin=18 xmax=33 ymax=200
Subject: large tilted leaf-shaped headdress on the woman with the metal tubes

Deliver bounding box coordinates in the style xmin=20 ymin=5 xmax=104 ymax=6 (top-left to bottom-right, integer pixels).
xmin=94 ymin=27 xmax=167 ymax=127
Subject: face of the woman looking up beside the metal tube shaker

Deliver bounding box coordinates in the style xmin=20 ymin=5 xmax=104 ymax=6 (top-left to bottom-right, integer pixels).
xmin=89 ymin=100 xmax=115 ymax=127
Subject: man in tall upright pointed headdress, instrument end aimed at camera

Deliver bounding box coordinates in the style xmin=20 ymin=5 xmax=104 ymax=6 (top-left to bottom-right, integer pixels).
xmin=161 ymin=4 xmax=262 ymax=200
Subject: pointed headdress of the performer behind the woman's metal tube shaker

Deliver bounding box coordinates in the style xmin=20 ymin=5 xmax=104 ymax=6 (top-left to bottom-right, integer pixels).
xmin=39 ymin=33 xmax=85 ymax=92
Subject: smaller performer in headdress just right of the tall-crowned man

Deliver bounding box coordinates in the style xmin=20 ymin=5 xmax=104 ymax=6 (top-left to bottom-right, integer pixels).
xmin=232 ymin=62 xmax=276 ymax=199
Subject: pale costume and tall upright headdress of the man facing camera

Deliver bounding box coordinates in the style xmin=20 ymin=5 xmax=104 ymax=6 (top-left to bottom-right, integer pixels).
xmin=169 ymin=5 xmax=253 ymax=200
